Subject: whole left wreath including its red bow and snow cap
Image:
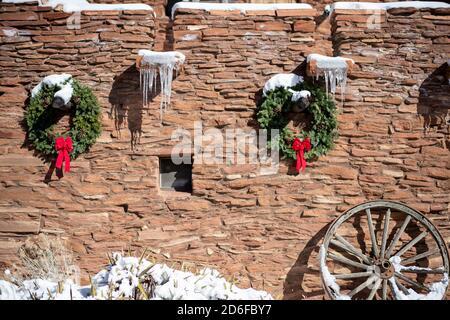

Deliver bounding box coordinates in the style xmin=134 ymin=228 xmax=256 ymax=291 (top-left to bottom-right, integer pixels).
xmin=25 ymin=75 xmax=101 ymax=172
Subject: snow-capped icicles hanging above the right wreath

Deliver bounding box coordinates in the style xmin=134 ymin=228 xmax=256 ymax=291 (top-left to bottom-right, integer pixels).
xmin=306 ymin=53 xmax=354 ymax=101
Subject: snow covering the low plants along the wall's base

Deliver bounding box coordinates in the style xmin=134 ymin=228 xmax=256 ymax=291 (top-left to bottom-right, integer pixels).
xmin=0 ymin=253 xmax=272 ymax=300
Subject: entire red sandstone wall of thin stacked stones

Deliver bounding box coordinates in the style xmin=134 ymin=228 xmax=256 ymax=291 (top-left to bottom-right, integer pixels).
xmin=0 ymin=4 xmax=450 ymax=298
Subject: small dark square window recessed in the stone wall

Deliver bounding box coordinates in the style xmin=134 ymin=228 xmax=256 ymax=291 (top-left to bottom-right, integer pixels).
xmin=159 ymin=158 xmax=192 ymax=192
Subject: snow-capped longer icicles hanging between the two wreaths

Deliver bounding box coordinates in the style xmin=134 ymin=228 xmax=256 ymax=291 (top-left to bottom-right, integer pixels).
xmin=139 ymin=50 xmax=185 ymax=120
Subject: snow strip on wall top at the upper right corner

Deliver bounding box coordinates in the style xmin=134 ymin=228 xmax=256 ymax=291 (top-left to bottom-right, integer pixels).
xmin=330 ymin=1 xmax=450 ymax=11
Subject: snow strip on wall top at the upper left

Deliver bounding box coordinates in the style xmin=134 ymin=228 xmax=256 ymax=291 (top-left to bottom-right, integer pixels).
xmin=2 ymin=0 xmax=153 ymax=12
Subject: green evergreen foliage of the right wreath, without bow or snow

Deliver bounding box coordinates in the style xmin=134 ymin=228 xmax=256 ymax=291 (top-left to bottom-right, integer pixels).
xmin=257 ymin=81 xmax=338 ymax=160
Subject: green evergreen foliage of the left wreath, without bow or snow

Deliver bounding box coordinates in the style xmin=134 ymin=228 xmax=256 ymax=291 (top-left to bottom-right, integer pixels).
xmin=25 ymin=79 xmax=101 ymax=160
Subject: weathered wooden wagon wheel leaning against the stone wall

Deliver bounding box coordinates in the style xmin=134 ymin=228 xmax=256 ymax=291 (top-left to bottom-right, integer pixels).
xmin=319 ymin=201 xmax=449 ymax=300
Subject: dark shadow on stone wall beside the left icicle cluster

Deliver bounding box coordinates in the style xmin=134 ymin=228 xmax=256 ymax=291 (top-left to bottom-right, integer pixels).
xmin=109 ymin=64 xmax=160 ymax=150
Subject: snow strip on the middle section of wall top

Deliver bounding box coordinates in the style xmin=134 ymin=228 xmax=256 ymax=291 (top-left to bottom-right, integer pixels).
xmin=172 ymin=2 xmax=313 ymax=20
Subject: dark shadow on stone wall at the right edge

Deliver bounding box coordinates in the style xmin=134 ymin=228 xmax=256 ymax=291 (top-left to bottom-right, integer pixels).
xmin=417 ymin=63 xmax=450 ymax=142
